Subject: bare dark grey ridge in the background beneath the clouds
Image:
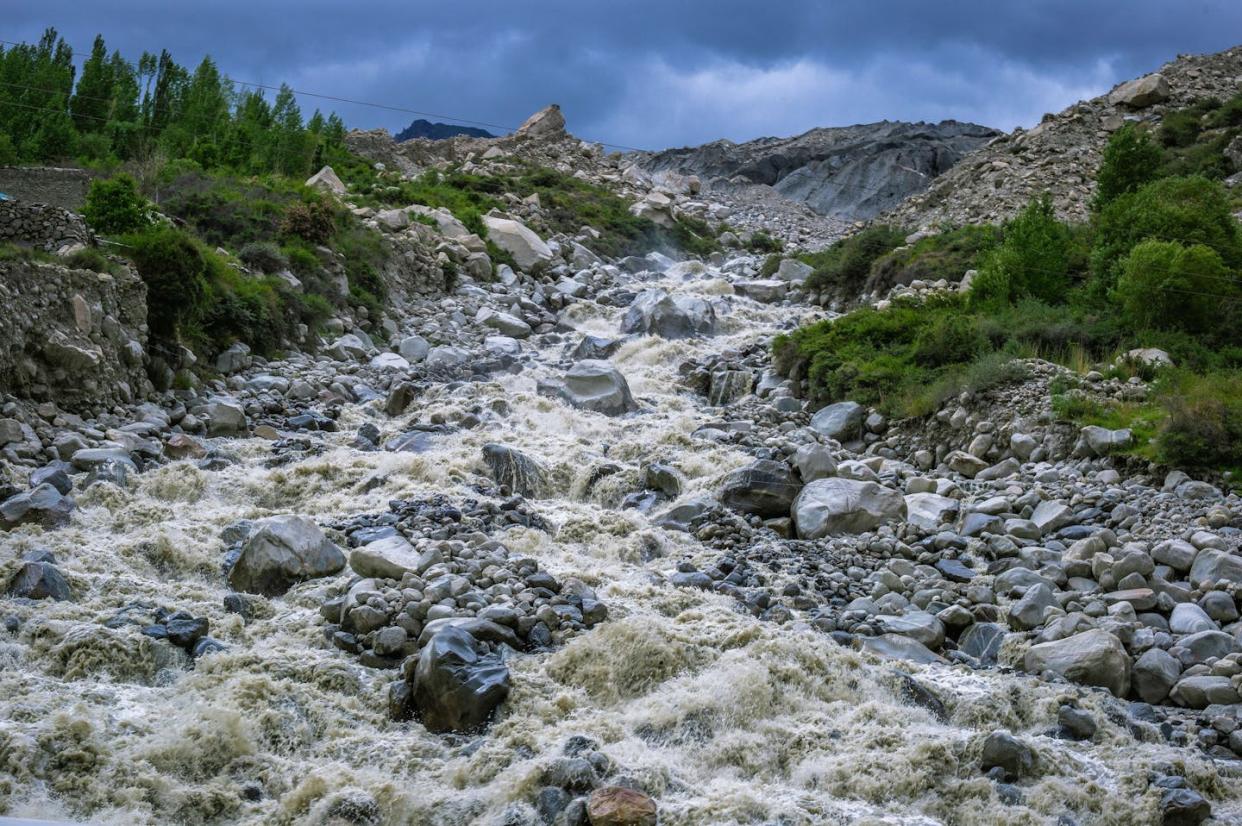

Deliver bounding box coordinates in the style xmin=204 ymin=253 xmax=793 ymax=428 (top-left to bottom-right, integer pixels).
xmin=641 ymin=120 xmax=1001 ymax=220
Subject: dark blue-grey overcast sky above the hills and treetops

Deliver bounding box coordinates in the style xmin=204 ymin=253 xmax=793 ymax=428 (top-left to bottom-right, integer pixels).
xmin=9 ymin=0 xmax=1242 ymax=148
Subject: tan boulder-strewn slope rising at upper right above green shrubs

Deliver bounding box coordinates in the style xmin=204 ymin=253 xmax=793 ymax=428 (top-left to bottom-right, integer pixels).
xmin=884 ymin=47 xmax=1242 ymax=227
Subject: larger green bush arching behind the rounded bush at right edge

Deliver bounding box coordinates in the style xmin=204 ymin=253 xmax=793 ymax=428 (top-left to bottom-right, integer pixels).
xmin=1092 ymin=176 xmax=1242 ymax=297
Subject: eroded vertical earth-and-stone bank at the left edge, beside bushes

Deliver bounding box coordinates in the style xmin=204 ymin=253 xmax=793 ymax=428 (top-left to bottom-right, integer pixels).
xmin=0 ymin=261 xmax=152 ymax=411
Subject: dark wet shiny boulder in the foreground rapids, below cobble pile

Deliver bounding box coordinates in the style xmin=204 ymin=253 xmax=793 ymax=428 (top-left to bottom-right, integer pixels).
xmin=410 ymin=626 xmax=509 ymax=733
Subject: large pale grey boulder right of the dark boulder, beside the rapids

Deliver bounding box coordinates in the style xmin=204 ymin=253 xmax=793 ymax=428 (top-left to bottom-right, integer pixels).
xmin=791 ymin=478 xmax=905 ymax=539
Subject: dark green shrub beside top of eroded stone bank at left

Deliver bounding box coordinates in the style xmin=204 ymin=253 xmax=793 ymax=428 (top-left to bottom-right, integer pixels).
xmin=123 ymin=227 xmax=210 ymax=340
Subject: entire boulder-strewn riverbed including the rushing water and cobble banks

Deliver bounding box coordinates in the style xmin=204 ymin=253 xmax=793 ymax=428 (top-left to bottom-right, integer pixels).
xmin=0 ymin=242 xmax=1242 ymax=826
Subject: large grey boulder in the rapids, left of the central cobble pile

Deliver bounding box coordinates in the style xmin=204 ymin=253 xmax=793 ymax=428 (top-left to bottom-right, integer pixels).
xmin=229 ymin=515 xmax=345 ymax=596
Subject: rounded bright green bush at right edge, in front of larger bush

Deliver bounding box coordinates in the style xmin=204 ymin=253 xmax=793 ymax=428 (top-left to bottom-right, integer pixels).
xmin=1114 ymin=241 xmax=1242 ymax=333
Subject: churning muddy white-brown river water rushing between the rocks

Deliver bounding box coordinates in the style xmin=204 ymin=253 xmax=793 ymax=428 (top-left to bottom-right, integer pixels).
xmin=0 ymin=259 xmax=1242 ymax=826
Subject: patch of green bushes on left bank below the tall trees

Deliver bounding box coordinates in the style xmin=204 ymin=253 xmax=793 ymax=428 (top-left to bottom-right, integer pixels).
xmin=86 ymin=167 xmax=372 ymax=355
